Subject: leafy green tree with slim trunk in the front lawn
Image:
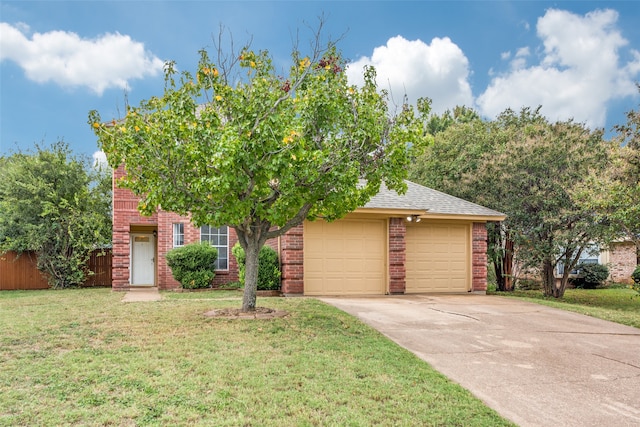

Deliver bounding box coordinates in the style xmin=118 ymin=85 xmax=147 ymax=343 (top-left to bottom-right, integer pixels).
xmin=89 ymin=29 xmax=422 ymax=311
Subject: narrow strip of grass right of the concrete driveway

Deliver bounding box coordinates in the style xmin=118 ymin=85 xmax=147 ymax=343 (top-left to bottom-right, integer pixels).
xmin=494 ymin=288 xmax=640 ymax=328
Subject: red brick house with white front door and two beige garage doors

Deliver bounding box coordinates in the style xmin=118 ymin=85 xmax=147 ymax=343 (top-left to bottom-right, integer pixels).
xmin=112 ymin=168 xmax=505 ymax=295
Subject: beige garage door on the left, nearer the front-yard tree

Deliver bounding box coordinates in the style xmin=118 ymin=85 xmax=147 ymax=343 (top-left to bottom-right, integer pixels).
xmin=304 ymin=219 xmax=387 ymax=295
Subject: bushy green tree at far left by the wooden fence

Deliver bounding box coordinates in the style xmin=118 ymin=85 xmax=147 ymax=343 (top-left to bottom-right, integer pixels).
xmin=0 ymin=142 xmax=111 ymax=288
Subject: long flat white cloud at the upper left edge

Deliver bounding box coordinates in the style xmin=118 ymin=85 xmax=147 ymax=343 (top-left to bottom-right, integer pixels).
xmin=0 ymin=22 xmax=163 ymax=95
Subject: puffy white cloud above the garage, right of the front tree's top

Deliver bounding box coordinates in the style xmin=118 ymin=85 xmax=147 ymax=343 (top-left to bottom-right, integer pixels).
xmin=346 ymin=36 xmax=473 ymax=113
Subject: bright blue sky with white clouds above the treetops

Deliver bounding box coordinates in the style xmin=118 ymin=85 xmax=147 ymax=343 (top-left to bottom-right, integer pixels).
xmin=0 ymin=0 xmax=640 ymax=163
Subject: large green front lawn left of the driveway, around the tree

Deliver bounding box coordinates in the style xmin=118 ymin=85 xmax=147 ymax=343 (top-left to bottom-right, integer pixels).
xmin=0 ymin=289 xmax=511 ymax=426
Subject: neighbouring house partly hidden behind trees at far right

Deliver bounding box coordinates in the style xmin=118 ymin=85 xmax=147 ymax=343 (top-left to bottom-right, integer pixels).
xmin=556 ymin=240 xmax=638 ymax=283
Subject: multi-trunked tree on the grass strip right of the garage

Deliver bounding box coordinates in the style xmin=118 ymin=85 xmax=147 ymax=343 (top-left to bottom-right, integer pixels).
xmin=496 ymin=116 xmax=608 ymax=298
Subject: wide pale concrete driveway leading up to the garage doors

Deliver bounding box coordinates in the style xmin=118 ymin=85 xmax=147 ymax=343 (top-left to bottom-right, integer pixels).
xmin=321 ymin=295 xmax=640 ymax=427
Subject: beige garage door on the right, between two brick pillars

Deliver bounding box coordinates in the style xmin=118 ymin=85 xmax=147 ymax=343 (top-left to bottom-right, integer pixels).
xmin=405 ymin=222 xmax=471 ymax=293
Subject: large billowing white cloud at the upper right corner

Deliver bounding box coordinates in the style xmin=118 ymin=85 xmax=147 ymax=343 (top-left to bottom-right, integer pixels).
xmin=477 ymin=9 xmax=640 ymax=127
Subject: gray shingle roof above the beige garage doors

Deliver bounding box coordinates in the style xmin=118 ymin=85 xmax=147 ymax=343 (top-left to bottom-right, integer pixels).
xmin=364 ymin=181 xmax=504 ymax=217
